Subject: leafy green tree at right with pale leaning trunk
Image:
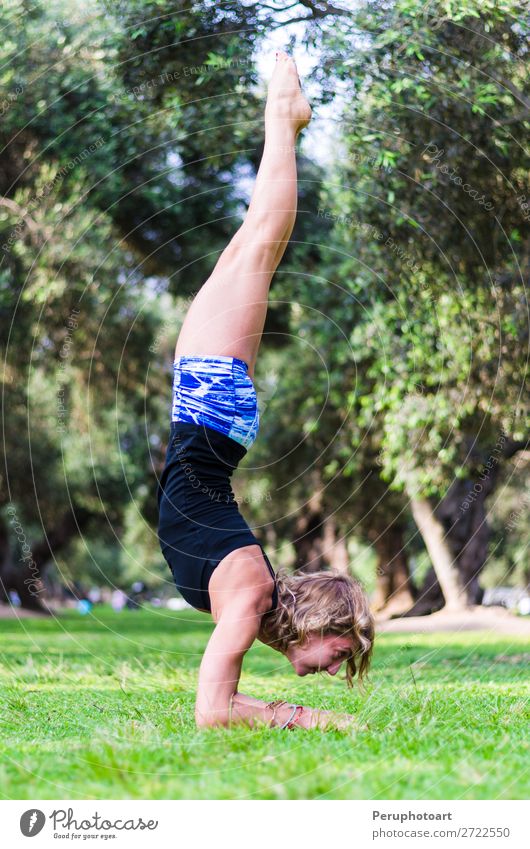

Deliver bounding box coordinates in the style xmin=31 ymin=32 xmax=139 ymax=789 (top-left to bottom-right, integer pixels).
xmin=318 ymin=0 xmax=530 ymax=607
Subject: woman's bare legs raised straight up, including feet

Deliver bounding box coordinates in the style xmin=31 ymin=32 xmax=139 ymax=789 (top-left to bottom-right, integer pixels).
xmin=175 ymin=53 xmax=311 ymax=377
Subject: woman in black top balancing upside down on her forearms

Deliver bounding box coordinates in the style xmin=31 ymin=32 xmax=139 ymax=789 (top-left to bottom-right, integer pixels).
xmin=158 ymin=53 xmax=373 ymax=728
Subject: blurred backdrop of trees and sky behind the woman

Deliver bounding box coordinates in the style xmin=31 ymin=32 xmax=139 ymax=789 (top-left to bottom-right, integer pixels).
xmin=0 ymin=0 xmax=530 ymax=617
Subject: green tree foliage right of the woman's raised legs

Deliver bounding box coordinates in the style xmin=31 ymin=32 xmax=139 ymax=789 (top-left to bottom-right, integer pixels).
xmin=242 ymin=0 xmax=530 ymax=580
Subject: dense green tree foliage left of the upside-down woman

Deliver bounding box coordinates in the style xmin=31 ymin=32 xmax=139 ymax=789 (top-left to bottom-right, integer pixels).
xmin=0 ymin=0 xmax=264 ymax=580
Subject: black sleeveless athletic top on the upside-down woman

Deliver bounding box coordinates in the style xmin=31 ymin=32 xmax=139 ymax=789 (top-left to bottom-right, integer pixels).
xmin=158 ymin=421 xmax=278 ymax=611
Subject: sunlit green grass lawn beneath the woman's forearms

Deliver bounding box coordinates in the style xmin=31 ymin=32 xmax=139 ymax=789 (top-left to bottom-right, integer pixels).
xmin=0 ymin=609 xmax=530 ymax=799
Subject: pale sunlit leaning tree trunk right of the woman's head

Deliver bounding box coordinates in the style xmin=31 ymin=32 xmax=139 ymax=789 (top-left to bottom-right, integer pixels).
xmin=410 ymin=498 xmax=467 ymax=611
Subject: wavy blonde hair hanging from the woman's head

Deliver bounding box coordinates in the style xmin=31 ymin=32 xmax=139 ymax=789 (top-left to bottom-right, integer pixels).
xmin=262 ymin=570 xmax=374 ymax=687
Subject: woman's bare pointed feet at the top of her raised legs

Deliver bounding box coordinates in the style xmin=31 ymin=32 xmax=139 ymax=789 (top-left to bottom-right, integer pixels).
xmin=265 ymin=51 xmax=311 ymax=135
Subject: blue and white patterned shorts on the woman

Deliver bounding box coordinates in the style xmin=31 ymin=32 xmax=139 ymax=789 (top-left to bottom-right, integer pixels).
xmin=171 ymin=356 xmax=259 ymax=449
